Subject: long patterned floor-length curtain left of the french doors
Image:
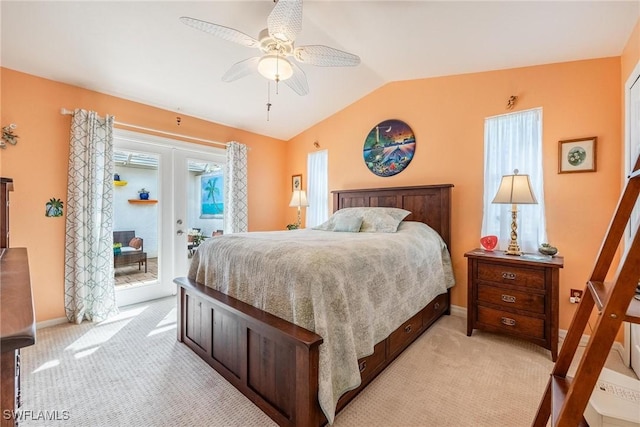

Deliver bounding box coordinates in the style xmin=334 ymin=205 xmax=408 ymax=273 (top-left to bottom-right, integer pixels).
xmin=64 ymin=110 xmax=118 ymax=324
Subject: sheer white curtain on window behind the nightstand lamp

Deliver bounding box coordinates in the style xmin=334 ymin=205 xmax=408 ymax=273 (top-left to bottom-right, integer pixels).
xmin=482 ymin=108 xmax=547 ymax=253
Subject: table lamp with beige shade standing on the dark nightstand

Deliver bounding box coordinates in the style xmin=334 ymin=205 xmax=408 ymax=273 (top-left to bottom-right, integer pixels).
xmin=492 ymin=169 xmax=538 ymax=255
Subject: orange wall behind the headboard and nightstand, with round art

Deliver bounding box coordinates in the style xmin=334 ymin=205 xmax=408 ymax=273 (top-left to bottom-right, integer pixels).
xmin=287 ymin=57 xmax=622 ymax=329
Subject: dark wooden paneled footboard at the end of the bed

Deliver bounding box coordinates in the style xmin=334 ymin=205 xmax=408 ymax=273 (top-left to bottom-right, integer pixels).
xmin=174 ymin=278 xmax=322 ymax=426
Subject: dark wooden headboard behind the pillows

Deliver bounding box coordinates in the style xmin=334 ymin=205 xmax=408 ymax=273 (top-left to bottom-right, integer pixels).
xmin=331 ymin=184 xmax=453 ymax=253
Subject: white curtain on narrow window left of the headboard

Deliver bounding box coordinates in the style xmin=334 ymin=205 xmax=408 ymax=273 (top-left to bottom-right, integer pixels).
xmin=305 ymin=150 xmax=329 ymax=227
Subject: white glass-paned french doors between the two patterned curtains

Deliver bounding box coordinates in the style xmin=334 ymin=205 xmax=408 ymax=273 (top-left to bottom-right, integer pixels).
xmin=114 ymin=129 xmax=225 ymax=306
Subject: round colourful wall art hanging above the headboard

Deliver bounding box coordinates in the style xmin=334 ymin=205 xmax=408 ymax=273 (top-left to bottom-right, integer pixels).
xmin=362 ymin=120 xmax=416 ymax=176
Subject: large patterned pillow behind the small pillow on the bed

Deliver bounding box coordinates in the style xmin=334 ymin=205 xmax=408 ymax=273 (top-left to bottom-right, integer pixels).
xmin=313 ymin=207 xmax=411 ymax=233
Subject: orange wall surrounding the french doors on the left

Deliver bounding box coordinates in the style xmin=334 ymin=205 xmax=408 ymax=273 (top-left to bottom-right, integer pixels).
xmin=0 ymin=68 xmax=290 ymax=321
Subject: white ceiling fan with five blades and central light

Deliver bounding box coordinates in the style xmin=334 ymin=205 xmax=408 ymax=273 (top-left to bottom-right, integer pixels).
xmin=180 ymin=0 xmax=360 ymax=95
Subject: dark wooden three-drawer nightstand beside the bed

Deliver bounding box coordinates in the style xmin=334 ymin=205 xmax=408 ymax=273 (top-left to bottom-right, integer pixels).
xmin=464 ymin=249 xmax=564 ymax=362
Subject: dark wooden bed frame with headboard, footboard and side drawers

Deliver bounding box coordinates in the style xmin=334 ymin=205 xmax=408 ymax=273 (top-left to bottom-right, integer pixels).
xmin=174 ymin=184 xmax=453 ymax=426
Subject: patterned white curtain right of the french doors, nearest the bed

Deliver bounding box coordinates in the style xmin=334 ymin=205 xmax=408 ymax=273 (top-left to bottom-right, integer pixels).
xmin=224 ymin=141 xmax=248 ymax=234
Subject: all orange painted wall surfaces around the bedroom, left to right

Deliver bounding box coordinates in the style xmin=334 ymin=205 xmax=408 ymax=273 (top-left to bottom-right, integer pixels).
xmin=5 ymin=21 xmax=640 ymax=329
